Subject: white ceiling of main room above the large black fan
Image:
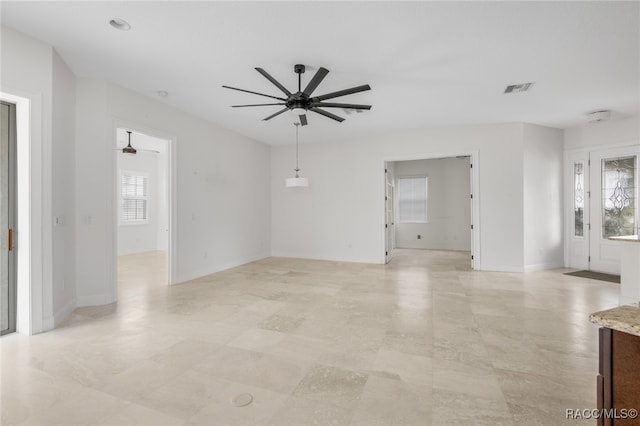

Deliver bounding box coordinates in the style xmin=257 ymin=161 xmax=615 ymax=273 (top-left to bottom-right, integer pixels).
xmin=0 ymin=0 xmax=640 ymax=144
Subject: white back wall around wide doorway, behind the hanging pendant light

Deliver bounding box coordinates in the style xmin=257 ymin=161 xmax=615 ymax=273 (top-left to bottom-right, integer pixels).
xmin=271 ymin=124 xmax=524 ymax=271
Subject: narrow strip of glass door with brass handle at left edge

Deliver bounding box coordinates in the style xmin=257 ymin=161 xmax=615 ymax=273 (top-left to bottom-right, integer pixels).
xmin=0 ymin=102 xmax=17 ymax=335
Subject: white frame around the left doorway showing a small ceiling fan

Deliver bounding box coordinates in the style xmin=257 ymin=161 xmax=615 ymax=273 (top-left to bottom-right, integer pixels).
xmin=109 ymin=118 xmax=178 ymax=301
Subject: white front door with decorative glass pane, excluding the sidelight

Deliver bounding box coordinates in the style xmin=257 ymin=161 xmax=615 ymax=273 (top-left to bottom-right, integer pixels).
xmin=589 ymin=146 xmax=640 ymax=274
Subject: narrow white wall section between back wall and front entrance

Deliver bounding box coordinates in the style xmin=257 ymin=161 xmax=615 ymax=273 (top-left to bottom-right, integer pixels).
xmin=523 ymin=124 xmax=564 ymax=271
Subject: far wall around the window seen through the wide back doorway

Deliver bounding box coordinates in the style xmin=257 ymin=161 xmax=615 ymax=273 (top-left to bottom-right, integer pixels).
xmin=395 ymin=157 xmax=471 ymax=251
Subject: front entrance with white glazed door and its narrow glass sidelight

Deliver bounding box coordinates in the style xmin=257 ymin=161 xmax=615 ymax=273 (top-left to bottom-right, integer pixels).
xmin=566 ymin=145 xmax=640 ymax=275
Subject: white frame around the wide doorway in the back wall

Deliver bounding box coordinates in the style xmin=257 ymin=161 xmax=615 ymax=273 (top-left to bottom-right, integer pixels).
xmin=378 ymin=150 xmax=482 ymax=271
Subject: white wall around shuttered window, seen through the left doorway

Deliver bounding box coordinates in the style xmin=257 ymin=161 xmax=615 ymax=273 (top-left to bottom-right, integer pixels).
xmin=116 ymin=149 xmax=162 ymax=256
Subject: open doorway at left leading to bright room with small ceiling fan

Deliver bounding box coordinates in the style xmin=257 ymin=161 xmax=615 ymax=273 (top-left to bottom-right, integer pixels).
xmin=115 ymin=127 xmax=171 ymax=291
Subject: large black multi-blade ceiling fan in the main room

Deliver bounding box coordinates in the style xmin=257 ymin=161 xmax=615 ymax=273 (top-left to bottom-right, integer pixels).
xmin=222 ymin=64 xmax=371 ymax=126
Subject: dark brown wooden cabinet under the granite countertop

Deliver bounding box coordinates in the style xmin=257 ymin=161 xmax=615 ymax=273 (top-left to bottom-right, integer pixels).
xmin=597 ymin=327 xmax=640 ymax=426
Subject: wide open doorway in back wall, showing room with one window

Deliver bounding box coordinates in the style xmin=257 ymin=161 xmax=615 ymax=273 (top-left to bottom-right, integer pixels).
xmin=385 ymin=155 xmax=480 ymax=269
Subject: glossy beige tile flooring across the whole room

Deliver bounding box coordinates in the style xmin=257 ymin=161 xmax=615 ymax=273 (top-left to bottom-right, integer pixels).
xmin=1 ymin=250 xmax=619 ymax=426
